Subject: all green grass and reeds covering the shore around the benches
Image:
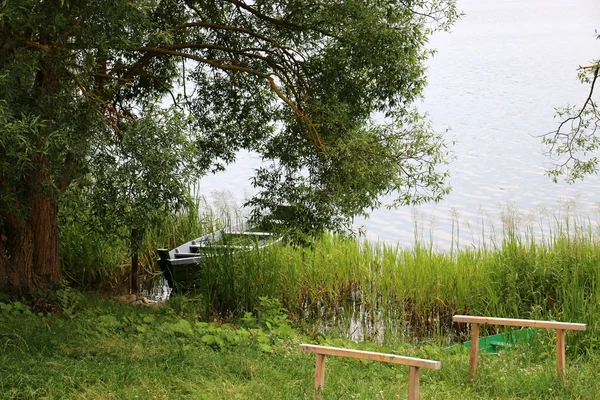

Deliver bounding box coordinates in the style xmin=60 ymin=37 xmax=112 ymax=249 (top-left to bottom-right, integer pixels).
xmin=0 ymin=203 xmax=600 ymax=399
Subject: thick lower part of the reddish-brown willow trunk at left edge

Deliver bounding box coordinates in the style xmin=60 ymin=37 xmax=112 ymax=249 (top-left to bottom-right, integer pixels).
xmin=0 ymin=159 xmax=60 ymax=296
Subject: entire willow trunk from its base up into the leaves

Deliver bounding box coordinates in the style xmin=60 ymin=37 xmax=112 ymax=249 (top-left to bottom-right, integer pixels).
xmin=0 ymin=39 xmax=66 ymax=295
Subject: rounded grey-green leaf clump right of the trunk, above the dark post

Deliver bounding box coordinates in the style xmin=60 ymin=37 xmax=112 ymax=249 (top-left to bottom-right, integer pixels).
xmin=77 ymin=105 xmax=197 ymax=237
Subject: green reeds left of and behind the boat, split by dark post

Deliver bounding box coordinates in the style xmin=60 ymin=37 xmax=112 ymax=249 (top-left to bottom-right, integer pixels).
xmin=59 ymin=186 xmax=210 ymax=289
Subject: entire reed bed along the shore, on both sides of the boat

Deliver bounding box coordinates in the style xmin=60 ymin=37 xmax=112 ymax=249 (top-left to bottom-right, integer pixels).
xmin=61 ymin=202 xmax=600 ymax=352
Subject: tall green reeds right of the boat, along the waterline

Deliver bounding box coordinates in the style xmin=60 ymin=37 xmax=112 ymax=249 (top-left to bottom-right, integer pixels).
xmin=190 ymin=211 xmax=600 ymax=351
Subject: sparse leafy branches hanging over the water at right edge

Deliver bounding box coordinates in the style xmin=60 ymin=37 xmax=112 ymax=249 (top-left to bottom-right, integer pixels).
xmin=542 ymin=35 xmax=600 ymax=183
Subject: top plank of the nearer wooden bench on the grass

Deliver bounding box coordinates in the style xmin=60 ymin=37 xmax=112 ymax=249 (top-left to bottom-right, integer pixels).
xmin=300 ymin=344 xmax=442 ymax=369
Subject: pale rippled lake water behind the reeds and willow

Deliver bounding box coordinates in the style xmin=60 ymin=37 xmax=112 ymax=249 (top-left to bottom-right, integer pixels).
xmin=200 ymin=0 xmax=600 ymax=249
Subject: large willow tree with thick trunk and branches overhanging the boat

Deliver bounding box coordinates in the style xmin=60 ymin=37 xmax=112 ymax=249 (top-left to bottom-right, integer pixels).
xmin=0 ymin=0 xmax=456 ymax=293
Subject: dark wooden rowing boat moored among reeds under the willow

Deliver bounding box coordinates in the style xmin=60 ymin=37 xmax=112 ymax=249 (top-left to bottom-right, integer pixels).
xmin=157 ymin=225 xmax=282 ymax=292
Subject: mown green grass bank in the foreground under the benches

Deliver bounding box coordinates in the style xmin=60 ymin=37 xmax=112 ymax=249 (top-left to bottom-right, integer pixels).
xmin=0 ymin=293 xmax=600 ymax=400
